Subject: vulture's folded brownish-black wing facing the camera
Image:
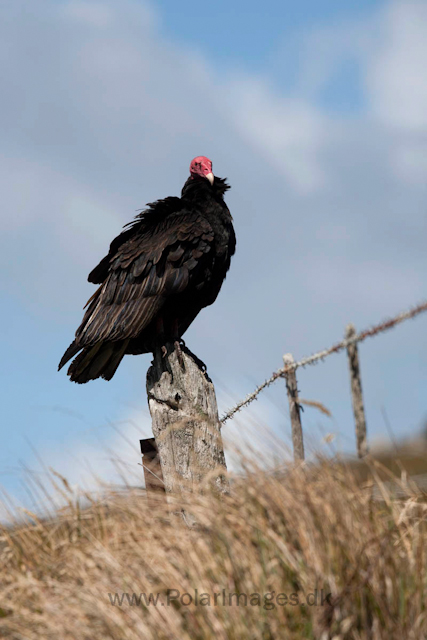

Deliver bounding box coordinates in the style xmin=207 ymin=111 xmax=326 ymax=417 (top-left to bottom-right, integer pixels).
xmin=75 ymin=210 xmax=214 ymax=347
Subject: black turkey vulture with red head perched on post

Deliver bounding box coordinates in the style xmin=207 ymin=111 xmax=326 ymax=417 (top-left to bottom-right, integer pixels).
xmin=59 ymin=156 xmax=236 ymax=383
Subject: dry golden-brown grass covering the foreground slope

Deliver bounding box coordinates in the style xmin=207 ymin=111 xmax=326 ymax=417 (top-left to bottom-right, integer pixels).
xmin=0 ymin=462 xmax=427 ymax=640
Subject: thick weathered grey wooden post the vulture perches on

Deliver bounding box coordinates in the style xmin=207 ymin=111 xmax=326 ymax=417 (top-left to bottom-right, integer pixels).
xmin=147 ymin=344 xmax=228 ymax=493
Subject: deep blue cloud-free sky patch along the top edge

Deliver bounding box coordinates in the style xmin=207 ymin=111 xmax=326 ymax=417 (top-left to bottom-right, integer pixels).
xmin=160 ymin=0 xmax=385 ymax=65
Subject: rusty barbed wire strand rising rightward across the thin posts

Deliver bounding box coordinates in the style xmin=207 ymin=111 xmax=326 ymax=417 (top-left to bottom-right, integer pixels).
xmin=221 ymin=302 xmax=427 ymax=424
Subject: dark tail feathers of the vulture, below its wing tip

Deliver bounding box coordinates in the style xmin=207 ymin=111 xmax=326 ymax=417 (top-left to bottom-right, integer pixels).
xmin=67 ymin=340 xmax=129 ymax=384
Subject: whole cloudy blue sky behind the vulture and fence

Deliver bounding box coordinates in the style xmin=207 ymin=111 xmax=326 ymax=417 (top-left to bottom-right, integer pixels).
xmin=0 ymin=0 xmax=427 ymax=510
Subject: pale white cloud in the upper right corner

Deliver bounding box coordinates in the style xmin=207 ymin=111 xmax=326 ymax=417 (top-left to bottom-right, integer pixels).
xmin=367 ymin=0 xmax=427 ymax=186
